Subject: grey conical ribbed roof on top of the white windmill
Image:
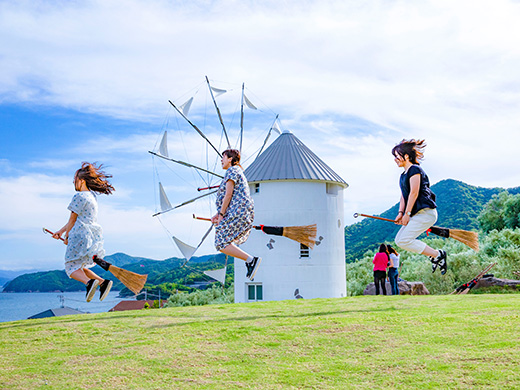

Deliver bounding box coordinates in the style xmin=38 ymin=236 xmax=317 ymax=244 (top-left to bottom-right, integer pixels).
xmin=244 ymin=132 xmax=348 ymax=187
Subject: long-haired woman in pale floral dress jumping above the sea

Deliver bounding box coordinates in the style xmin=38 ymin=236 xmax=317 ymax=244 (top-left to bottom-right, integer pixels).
xmin=53 ymin=162 xmax=114 ymax=302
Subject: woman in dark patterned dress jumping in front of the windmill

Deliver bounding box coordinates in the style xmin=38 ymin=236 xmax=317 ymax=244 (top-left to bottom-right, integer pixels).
xmin=211 ymin=149 xmax=262 ymax=280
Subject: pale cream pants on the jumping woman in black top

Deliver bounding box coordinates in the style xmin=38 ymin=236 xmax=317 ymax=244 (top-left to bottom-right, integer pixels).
xmin=395 ymin=209 xmax=437 ymax=253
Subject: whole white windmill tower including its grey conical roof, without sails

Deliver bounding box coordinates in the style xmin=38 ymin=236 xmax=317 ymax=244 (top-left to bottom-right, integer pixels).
xmin=235 ymin=131 xmax=348 ymax=302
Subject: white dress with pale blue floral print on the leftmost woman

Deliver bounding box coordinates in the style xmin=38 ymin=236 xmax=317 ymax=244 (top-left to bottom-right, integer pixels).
xmin=65 ymin=191 xmax=105 ymax=278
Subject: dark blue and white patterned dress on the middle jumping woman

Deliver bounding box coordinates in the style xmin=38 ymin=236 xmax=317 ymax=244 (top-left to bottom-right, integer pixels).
xmin=215 ymin=165 xmax=255 ymax=250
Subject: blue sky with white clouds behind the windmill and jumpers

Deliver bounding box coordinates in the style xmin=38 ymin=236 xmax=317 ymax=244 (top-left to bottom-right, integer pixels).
xmin=0 ymin=0 xmax=520 ymax=270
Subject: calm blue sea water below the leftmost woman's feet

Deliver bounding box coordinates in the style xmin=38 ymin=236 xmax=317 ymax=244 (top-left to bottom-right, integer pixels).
xmin=0 ymin=291 xmax=131 ymax=322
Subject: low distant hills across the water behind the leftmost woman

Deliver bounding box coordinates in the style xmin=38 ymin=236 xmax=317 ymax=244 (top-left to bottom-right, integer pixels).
xmin=4 ymin=253 xmax=229 ymax=295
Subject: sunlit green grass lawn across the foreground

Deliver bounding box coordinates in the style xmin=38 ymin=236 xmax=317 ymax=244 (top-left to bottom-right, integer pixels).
xmin=0 ymin=294 xmax=520 ymax=389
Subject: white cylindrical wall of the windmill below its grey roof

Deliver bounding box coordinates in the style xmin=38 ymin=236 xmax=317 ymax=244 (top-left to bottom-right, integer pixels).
xmin=235 ymin=181 xmax=346 ymax=302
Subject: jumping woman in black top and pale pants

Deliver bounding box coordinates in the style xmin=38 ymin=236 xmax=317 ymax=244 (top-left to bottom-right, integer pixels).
xmin=392 ymin=139 xmax=448 ymax=275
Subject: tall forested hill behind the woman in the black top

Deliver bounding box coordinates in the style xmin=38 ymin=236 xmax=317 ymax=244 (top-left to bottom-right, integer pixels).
xmin=345 ymin=179 xmax=520 ymax=263
